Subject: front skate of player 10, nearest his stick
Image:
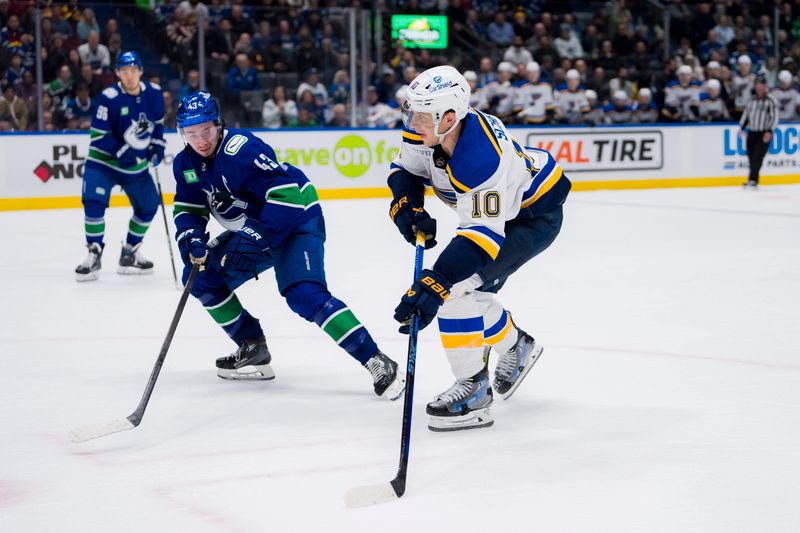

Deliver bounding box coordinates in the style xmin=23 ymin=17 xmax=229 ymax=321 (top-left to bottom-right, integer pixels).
xmin=425 ymin=367 xmax=494 ymax=431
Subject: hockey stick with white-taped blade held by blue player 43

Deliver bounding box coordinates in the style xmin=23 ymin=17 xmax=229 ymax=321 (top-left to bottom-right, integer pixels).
xmin=69 ymin=265 xmax=200 ymax=442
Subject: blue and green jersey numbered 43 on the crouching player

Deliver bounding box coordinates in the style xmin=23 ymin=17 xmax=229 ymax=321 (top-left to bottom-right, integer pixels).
xmin=172 ymin=129 xmax=322 ymax=248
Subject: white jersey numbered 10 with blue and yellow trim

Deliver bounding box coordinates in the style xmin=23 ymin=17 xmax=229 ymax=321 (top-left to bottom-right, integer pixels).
xmin=388 ymin=109 xmax=570 ymax=283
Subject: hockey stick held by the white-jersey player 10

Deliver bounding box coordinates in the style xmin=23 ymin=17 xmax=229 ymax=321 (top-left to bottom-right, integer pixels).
xmin=344 ymin=232 xmax=425 ymax=508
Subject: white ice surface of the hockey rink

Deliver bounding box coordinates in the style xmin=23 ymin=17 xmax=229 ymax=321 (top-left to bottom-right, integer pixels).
xmin=0 ymin=186 xmax=800 ymax=533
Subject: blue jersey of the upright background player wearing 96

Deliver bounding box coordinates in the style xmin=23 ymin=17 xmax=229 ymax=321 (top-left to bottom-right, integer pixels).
xmin=86 ymin=81 xmax=166 ymax=177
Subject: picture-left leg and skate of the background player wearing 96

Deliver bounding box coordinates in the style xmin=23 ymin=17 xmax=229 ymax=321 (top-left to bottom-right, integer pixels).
xmin=75 ymin=168 xmax=115 ymax=281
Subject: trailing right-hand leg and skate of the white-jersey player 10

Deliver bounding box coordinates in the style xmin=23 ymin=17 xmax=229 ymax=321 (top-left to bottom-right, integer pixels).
xmin=478 ymin=206 xmax=563 ymax=399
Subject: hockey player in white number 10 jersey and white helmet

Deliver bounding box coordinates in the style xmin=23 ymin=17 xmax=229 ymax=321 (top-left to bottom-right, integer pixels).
xmin=388 ymin=66 xmax=571 ymax=431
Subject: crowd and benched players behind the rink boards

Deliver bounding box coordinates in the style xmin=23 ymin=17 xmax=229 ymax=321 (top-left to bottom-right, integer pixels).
xmin=0 ymin=0 xmax=800 ymax=131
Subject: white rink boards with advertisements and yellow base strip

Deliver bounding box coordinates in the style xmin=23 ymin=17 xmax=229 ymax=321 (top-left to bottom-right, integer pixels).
xmin=0 ymin=123 xmax=800 ymax=211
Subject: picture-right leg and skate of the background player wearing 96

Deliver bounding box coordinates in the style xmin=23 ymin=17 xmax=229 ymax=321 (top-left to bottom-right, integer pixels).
xmin=117 ymin=172 xmax=160 ymax=275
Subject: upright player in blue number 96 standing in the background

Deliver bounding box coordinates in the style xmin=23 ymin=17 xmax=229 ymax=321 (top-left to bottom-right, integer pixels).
xmin=75 ymin=52 xmax=167 ymax=281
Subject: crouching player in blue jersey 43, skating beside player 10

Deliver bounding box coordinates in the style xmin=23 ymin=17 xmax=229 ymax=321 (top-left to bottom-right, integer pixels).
xmin=173 ymin=92 xmax=405 ymax=400
